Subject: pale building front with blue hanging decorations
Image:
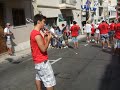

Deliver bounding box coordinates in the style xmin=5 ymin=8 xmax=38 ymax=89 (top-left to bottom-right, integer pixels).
xmin=81 ymin=0 xmax=99 ymax=25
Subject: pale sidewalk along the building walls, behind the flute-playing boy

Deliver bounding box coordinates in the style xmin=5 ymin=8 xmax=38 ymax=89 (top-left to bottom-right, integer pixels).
xmin=0 ymin=35 xmax=86 ymax=63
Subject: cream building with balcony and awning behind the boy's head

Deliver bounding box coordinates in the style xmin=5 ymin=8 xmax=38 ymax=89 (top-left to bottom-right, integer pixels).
xmin=34 ymin=0 xmax=81 ymax=26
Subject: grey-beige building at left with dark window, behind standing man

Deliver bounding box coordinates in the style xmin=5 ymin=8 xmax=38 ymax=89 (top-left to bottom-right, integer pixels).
xmin=0 ymin=0 xmax=33 ymax=52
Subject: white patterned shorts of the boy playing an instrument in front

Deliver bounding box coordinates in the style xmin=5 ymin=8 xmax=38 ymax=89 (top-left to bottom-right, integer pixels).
xmin=35 ymin=60 xmax=56 ymax=87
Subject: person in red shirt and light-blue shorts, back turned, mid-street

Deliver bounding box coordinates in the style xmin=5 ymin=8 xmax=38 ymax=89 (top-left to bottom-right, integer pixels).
xmin=70 ymin=21 xmax=80 ymax=48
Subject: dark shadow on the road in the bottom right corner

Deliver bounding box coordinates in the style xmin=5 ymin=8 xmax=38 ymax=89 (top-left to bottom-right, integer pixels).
xmin=99 ymin=55 xmax=120 ymax=90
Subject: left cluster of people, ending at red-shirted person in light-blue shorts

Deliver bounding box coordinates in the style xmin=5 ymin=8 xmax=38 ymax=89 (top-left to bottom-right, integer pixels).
xmin=50 ymin=21 xmax=80 ymax=48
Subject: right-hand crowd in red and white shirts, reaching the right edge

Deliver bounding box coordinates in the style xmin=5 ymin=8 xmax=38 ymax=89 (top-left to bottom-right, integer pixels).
xmin=84 ymin=18 xmax=120 ymax=55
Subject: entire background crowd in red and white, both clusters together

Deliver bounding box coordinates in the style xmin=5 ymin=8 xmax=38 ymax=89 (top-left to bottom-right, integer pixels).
xmin=47 ymin=18 xmax=120 ymax=54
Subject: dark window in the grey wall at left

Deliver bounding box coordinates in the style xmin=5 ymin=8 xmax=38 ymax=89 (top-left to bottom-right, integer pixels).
xmin=12 ymin=8 xmax=25 ymax=26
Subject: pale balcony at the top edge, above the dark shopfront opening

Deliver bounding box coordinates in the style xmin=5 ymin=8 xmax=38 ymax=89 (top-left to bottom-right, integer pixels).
xmin=59 ymin=0 xmax=77 ymax=9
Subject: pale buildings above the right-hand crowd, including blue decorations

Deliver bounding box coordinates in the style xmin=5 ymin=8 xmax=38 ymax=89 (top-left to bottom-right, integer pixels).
xmin=81 ymin=0 xmax=117 ymax=23
